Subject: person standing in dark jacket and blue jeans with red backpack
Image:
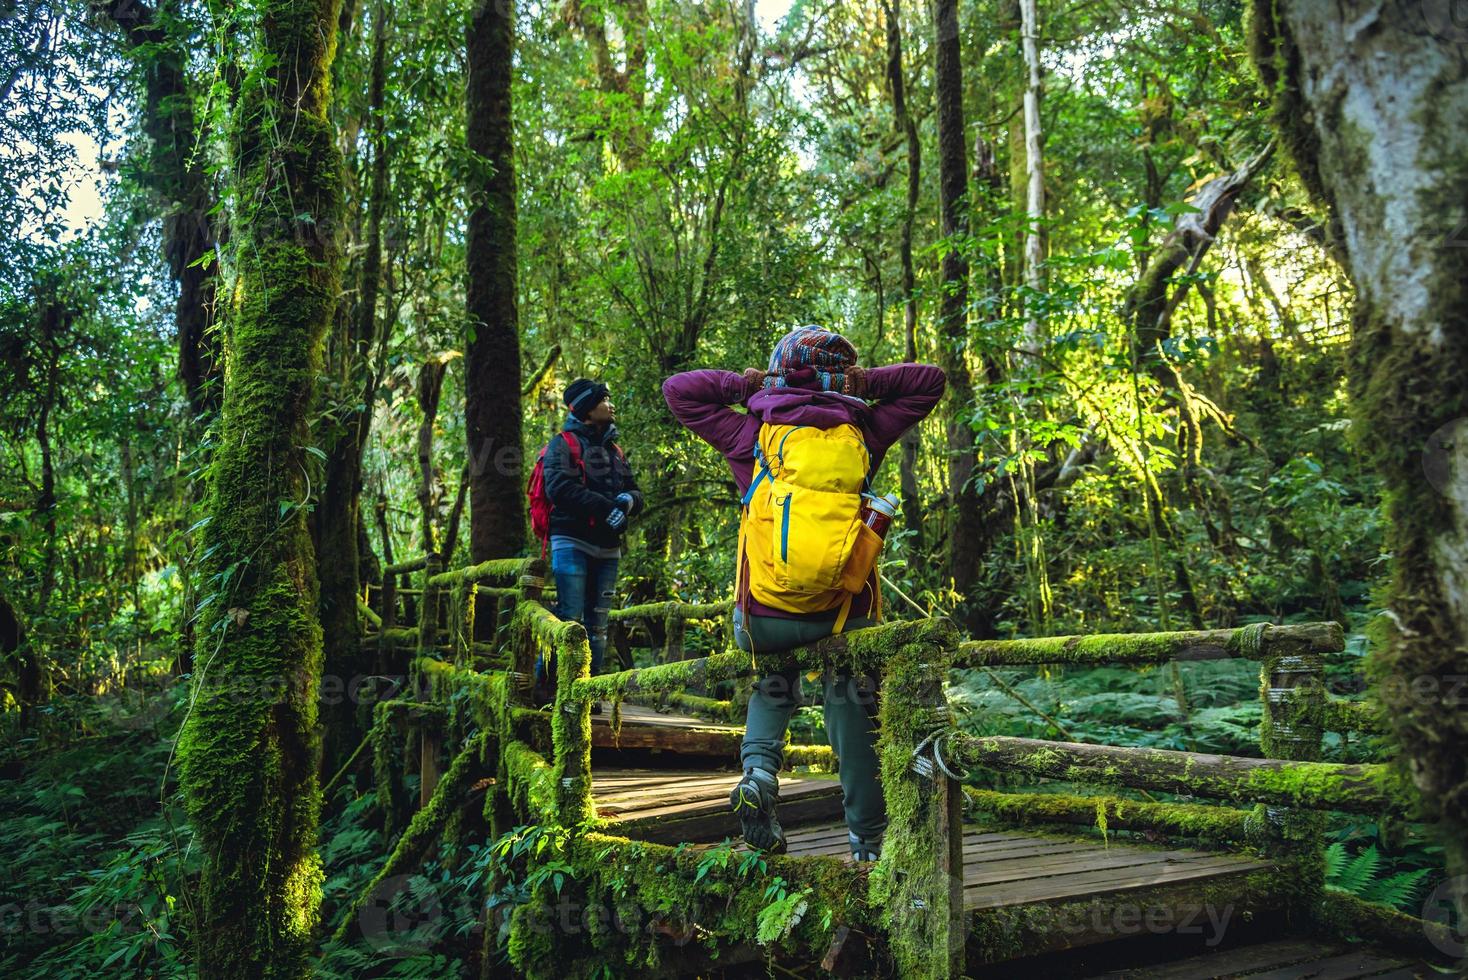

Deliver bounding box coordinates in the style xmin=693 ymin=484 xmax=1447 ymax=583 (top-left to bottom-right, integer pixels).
xmin=527 ymin=379 xmax=643 ymax=697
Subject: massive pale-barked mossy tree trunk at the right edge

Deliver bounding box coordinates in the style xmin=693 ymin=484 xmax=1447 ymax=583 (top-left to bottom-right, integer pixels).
xmin=1254 ymin=0 xmax=1468 ymax=923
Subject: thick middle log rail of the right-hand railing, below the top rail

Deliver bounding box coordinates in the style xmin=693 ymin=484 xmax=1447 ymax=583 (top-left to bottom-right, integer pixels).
xmin=942 ymin=732 xmax=1414 ymax=814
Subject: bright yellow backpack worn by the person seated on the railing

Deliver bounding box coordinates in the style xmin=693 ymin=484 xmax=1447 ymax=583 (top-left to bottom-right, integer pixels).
xmin=735 ymin=423 xmax=882 ymax=632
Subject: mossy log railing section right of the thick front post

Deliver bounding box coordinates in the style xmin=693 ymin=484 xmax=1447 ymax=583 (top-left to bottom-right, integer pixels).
xmin=938 ymin=624 xmax=1425 ymax=958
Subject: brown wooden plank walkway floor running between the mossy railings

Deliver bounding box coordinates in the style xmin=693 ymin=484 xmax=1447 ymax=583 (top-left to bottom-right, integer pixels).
xmin=578 ymin=703 xmax=1439 ymax=980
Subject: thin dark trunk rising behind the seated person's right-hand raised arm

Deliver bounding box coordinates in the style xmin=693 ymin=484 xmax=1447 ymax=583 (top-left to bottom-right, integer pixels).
xmin=882 ymin=0 xmax=928 ymax=555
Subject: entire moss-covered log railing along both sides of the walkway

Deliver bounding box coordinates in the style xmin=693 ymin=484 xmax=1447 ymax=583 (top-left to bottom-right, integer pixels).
xmin=346 ymin=556 xmax=1411 ymax=977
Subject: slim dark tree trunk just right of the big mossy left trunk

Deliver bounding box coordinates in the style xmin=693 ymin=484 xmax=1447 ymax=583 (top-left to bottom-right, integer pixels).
xmin=313 ymin=0 xmax=388 ymax=778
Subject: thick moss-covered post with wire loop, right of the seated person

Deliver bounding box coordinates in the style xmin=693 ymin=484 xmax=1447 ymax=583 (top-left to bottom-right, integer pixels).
xmin=871 ymin=627 xmax=967 ymax=977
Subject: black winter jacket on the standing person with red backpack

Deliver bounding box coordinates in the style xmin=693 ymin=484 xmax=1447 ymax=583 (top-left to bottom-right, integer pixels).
xmin=545 ymin=415 xmax=643 ymax=547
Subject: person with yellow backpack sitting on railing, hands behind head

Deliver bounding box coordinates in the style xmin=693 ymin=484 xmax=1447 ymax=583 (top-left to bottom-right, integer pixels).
xmin=662 ymin=326 xmax=944 ymax=861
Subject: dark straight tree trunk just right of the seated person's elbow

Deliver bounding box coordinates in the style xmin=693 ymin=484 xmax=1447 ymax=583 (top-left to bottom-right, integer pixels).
xmin=932 ymin=0 xmax=984 ymax=624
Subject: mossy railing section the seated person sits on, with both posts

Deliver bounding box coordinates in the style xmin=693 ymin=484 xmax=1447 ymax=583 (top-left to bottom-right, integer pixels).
xmin=496 ymin=616 xmax=966 ymax=977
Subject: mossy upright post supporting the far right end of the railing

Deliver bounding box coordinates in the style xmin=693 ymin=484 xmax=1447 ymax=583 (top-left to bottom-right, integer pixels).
xmin=1260 ymin=628 xmax=1326 ymax=918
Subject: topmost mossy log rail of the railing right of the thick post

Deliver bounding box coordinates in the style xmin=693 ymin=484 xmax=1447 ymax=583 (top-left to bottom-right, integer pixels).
xmin=953 ymin=622 xmax=1346 ymax=668
